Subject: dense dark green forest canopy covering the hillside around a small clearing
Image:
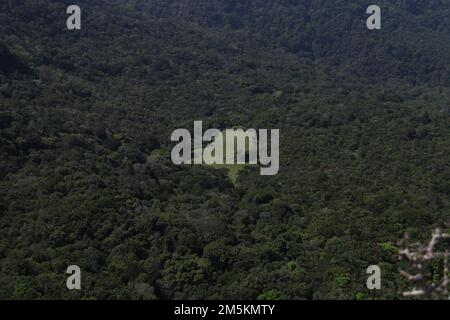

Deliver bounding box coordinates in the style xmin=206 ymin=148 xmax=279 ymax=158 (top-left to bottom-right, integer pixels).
xmin=0 ymin=0 xmax=450 ymax=299
